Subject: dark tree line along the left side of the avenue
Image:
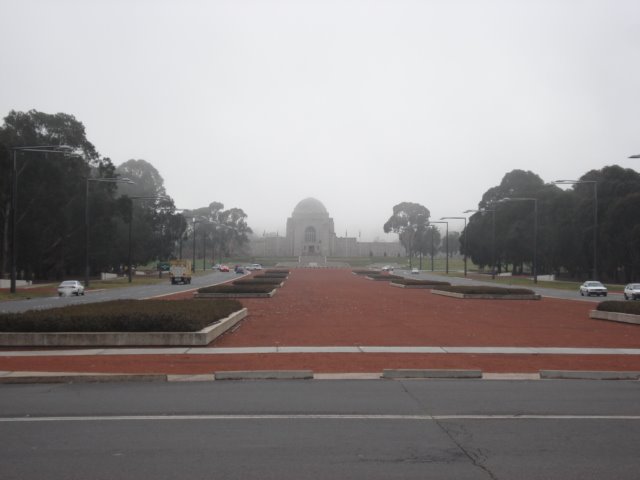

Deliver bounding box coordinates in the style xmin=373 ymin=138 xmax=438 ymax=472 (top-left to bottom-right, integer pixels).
xmin=0 ymin=110 xmax=251 ymax=280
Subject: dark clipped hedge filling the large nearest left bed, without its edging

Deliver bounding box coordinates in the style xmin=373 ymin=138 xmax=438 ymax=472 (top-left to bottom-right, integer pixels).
xmin=0 ymin=300 xmax=242 ymax=332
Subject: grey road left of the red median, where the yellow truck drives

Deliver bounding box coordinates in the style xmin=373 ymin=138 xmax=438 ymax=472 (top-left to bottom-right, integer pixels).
xmin=0 ymin=272 xmax=242 ymax=313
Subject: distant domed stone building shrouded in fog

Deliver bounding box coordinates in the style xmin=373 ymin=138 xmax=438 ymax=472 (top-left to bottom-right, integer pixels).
xmin=250 ymin=198 xmax=405 ymax=257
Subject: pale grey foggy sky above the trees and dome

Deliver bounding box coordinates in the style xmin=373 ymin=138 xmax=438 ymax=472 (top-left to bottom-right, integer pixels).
xmin=0 ymin=0 xmax=640 ymax=240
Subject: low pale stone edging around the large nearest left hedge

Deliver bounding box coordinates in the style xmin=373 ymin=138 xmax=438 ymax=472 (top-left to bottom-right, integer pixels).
xmin=0 ymin=308 xmax=247 ymax=347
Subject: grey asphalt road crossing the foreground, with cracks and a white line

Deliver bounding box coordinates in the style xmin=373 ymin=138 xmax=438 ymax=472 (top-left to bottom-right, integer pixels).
xmin=0 ymin=380 xmax=640 ymax=480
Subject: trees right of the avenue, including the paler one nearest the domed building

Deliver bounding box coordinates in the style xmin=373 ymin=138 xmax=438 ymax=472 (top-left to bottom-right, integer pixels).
xmin=383 ymin=165 xmax=640 ymax=283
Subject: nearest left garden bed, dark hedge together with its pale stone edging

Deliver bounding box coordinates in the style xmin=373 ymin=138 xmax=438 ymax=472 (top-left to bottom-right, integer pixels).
xmin=0 ymin=300 xmax=247 ymax=347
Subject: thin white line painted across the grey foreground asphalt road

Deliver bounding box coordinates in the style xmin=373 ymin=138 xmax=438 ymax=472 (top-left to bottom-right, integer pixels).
xmin=0 ymin=414 xmax=640 ymax=423
